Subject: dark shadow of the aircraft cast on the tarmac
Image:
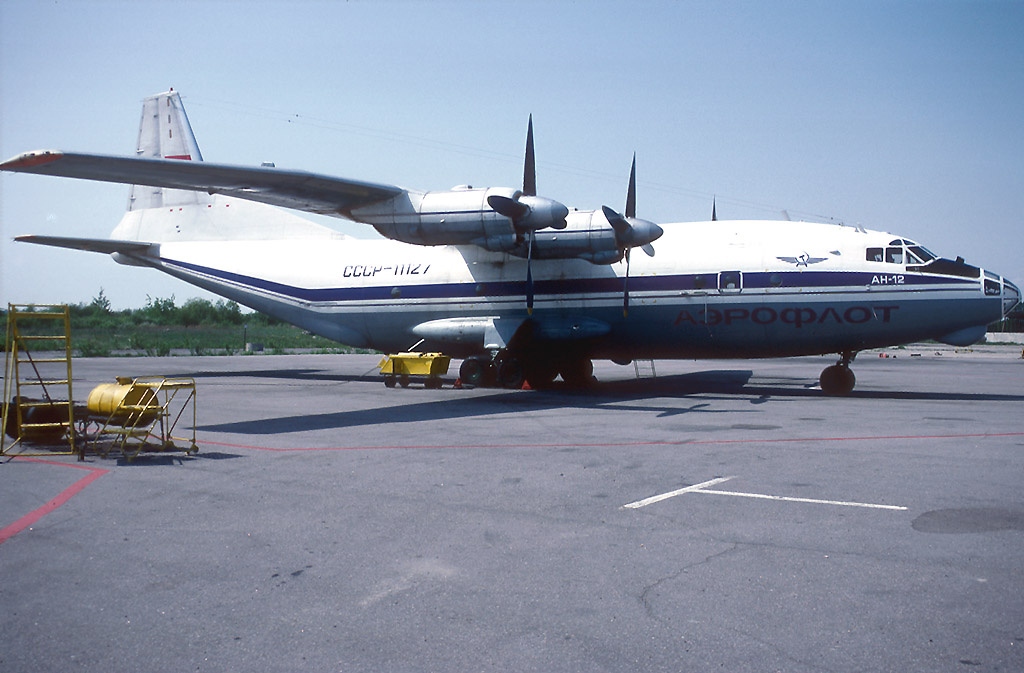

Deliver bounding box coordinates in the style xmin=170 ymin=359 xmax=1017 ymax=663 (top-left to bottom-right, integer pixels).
xmin=196 ymin=370 xmax=1024 ymax=435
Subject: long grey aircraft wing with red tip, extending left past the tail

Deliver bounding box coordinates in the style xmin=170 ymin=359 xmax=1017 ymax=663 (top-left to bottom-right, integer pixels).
xmin=0 ymin=150 xmax=404 ymax=217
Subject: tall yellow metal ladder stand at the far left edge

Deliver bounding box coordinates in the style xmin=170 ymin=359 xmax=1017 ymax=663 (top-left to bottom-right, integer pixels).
xmin=0 ymin=304 xmax=75 ymax=456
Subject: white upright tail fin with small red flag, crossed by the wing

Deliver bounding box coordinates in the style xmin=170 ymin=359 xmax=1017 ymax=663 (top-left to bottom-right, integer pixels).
xmin=128 ymin=88 xmax=211 ymax=211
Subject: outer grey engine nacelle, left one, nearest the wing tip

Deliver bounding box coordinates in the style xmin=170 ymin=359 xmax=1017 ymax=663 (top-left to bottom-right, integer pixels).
xmin=350 ymin=187 xmax=518 ymax=252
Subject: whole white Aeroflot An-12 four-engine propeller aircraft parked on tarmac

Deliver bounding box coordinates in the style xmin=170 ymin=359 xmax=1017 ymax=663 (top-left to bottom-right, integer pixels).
xmin=0 ymin=89 xmax=1021 ymax=394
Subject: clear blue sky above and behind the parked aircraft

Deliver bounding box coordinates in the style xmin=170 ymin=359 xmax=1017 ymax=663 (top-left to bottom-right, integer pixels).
xmin=0 ymin=0 xmax=1024 ymax=308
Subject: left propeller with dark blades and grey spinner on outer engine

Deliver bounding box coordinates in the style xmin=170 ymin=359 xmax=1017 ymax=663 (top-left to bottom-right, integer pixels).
xmin=487 ymin=115 xmax=569 ymax=314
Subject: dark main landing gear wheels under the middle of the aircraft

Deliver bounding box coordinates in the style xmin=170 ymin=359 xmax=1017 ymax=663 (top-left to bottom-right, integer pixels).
xmin=459 ymin=350 xmax=594 ymax=389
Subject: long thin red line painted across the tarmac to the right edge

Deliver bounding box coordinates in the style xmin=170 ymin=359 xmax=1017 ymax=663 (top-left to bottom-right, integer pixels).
xmin=199 ymin=432 xmax=1024 ymax=453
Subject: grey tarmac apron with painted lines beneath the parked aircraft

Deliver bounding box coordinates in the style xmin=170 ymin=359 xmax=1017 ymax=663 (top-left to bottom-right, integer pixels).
xmin=0 ymin=345 xmax=1024 ymax=673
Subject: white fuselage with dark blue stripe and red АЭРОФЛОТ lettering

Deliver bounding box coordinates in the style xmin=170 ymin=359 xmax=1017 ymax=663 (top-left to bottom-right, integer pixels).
xmin=138 ymin=204 xmax=1016 ymax=361
